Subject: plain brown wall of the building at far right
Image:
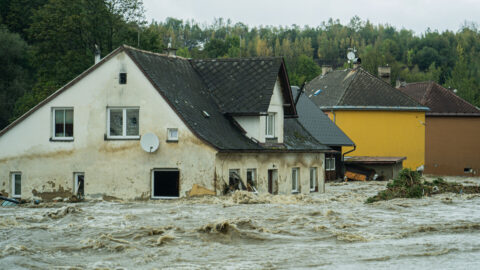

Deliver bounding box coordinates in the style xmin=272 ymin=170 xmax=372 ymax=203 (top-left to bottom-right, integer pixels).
xmin=425 ymin=116 xmax=480 ymax=176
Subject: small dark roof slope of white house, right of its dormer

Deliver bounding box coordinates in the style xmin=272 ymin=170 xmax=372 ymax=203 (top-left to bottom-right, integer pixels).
xmin=283 ymin=118 xmax=331 ymax=151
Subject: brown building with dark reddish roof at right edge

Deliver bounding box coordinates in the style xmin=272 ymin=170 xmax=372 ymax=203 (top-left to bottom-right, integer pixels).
xmin=398 ymin=82 xmax=480 ymax=176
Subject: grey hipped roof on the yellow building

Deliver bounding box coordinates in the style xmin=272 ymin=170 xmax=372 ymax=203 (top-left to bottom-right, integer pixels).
xmin=305 ymin=68 xmax=427 ymax=110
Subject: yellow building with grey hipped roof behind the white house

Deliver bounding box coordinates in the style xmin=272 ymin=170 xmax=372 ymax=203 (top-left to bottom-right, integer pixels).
xmin=305 ymin=68 xmax=428 ymax=169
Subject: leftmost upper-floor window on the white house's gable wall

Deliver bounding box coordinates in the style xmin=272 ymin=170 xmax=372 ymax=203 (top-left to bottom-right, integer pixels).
xmin=52 ymin=108 xmax=73 ymax=140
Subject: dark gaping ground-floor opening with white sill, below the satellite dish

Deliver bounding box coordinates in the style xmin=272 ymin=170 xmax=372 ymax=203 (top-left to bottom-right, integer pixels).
xmin=152 ymin=170 xmax=180 ymax=198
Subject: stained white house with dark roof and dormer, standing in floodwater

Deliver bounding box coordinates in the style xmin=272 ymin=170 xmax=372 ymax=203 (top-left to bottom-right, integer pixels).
xmin=0 ymin=46 xmax=332 ymax=200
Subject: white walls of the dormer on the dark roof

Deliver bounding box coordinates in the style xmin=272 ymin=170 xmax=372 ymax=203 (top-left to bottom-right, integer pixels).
xmin=234 ymin=78 xmax=284 ymax=143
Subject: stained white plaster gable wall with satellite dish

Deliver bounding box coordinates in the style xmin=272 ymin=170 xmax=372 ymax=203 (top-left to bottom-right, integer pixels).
xmin=0 ymin=52 xmax=216 ymax=199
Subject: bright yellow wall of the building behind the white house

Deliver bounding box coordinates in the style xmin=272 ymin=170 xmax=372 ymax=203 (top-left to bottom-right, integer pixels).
xmin=328 ymin=111 xmax=425 ymax=169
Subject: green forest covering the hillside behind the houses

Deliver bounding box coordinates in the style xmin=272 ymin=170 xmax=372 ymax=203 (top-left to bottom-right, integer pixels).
xmin=0 ymin=0 xmax=480 ymax=129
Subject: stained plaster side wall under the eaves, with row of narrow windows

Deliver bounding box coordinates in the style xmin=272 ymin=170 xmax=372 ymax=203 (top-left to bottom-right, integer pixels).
xmin=215 ymin=153 xmax=325 ymax=194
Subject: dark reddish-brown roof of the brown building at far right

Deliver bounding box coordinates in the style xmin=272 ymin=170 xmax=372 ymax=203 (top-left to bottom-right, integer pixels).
xmin=398 ymin=82 xmax=480 ymax=116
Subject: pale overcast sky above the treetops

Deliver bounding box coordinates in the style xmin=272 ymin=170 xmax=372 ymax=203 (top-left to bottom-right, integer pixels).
xmin=143 ymin=0 xmax=480 ymax=34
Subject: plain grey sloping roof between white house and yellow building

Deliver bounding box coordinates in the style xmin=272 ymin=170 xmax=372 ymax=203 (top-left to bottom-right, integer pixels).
xmin=292 ymin=86 xmax=354 ymax=146
